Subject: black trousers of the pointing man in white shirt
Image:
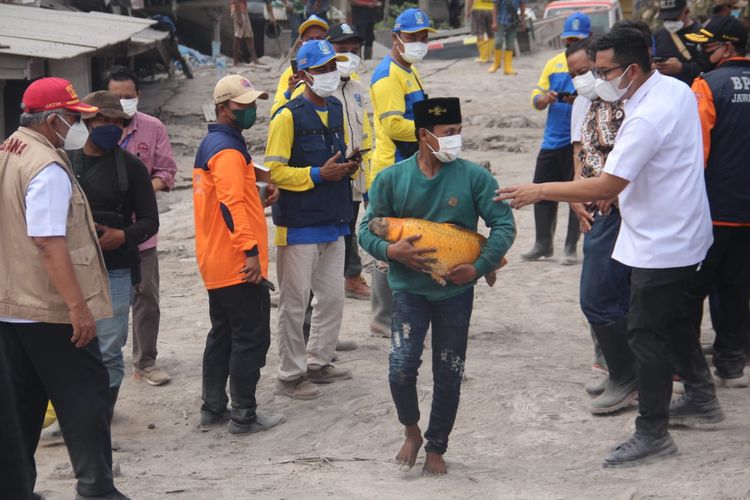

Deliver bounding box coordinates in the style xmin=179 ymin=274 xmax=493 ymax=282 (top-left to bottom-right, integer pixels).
xmin=628 ymin=266 xmax=716 ymax=437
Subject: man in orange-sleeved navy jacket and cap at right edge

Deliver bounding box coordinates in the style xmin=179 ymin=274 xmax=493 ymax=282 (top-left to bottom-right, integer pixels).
xmin=686 ymin=16 xmax=750 ymax=388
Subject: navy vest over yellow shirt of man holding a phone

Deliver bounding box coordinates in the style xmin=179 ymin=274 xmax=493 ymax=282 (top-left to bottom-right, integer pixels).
xmin=272 ymin=96 xmax=353 ymax=227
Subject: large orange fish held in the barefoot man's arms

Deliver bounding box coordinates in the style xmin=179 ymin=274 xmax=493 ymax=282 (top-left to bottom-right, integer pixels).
xmin=369 ymin=217 xmax=487 ymax=286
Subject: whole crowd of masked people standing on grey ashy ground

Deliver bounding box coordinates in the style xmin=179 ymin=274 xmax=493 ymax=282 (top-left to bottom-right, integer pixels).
xmin=0 ymin=0 xmax=750 ymax=499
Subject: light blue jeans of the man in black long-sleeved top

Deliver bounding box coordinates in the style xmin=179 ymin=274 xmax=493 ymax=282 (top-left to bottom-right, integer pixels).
xmin=96 ymin=269 xmax=133 ymax=387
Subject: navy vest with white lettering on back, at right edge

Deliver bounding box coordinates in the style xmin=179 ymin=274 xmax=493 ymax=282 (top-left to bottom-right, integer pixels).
xmin=703 ymin=60 xmax=750 ymax=223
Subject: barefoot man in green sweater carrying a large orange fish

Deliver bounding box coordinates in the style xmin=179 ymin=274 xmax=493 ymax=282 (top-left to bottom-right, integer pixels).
xmin=359 ymin=97 xmax=516 ymax=475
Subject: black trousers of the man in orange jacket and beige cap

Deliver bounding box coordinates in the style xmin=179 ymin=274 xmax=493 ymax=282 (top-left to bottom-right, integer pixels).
xmin=202 ymin=283 xmax=271 ymax=422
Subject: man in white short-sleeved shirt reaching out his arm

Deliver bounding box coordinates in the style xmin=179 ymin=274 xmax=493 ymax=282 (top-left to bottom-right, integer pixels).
xmin=497 ymin=28 xmax=724 ymax=467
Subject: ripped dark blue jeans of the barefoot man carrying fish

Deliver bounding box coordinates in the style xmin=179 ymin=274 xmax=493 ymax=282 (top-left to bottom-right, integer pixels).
xmin=388 ymin=288 xmax=474 ymax=454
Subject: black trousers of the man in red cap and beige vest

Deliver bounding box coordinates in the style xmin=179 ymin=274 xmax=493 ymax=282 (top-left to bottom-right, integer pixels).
xmin=0 ymin=322 xmax=115 ymax=496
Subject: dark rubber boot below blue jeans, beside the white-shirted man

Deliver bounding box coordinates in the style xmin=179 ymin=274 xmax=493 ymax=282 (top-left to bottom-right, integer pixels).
xmin=591 ymin=317 xmax=638 ymax=415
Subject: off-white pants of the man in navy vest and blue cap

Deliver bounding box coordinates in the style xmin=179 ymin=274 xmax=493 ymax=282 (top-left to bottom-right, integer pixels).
xmin=276 ymin=237 xmax=345 ymax=381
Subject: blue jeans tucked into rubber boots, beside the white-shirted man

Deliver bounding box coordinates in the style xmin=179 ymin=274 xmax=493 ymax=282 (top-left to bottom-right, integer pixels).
xmin=580 ymin=207 xmax=630 ymax=326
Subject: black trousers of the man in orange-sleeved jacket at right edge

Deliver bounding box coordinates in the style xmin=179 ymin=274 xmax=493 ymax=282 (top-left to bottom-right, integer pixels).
xmin=689 ymin=226 xmax=750 ymax=379
